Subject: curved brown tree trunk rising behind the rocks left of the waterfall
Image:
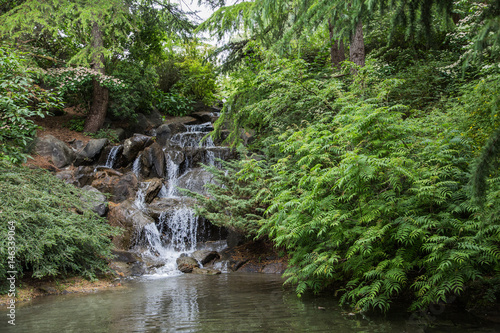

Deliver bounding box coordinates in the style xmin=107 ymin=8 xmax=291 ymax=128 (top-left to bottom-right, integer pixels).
xmin=83 ymin=22 xmax=109 ymax=133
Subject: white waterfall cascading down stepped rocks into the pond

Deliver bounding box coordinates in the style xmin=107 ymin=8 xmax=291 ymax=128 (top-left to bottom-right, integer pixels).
xmin=132 ymin=118 xmax=225 ymax=277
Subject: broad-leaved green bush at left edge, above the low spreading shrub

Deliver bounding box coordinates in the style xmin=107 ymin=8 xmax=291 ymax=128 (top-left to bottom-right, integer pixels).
xmin=0 ymin=46 xmax=61 ymax=163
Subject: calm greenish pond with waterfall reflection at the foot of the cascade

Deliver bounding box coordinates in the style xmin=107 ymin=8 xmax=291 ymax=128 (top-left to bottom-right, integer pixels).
xmin=0 ymin=273 xmax=498 ymax=333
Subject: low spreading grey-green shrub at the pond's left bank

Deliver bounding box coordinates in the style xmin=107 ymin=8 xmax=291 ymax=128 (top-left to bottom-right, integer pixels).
xmin=0 ymin=161 xmax=117 ymax=291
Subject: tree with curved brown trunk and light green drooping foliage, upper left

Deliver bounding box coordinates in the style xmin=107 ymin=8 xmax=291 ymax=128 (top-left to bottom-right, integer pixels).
xmin=0 ymin=0 xmax=190 ymax=132
